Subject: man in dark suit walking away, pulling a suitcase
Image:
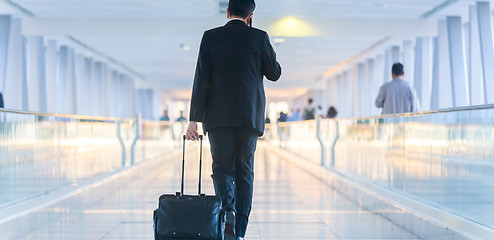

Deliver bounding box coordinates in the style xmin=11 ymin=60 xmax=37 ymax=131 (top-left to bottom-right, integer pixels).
xmin=186 ymin=0 xmax=281 ymax=240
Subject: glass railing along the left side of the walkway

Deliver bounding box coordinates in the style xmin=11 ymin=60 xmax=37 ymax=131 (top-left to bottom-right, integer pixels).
xmin=0 ymin=109 xmax=177 ymax=209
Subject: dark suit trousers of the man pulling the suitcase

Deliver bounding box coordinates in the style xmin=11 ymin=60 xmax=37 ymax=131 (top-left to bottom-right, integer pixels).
xmin=208 ymin=127 xmax=259 ymax=237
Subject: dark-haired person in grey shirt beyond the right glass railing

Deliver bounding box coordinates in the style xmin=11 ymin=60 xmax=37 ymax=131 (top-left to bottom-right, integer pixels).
xmin=376 ymin=63 xmax=419 ymax=114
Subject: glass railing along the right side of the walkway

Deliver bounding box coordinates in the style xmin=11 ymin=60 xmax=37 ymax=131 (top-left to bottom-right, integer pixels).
xmin=267 ymin=105 xmax=494 ymax=231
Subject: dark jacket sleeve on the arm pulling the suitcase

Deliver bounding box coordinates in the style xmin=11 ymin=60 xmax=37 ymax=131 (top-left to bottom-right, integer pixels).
xmin=189 ymin=33 xmax=211 ymax=122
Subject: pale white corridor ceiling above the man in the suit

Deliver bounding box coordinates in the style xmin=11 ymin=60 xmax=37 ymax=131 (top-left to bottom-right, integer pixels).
xmin=1 ymin=0 xmax=484 ymax=93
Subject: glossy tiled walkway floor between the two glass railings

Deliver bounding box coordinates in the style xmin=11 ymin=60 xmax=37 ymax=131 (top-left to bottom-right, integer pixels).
xmin=0 ymin=143 xmax=417 ymax=240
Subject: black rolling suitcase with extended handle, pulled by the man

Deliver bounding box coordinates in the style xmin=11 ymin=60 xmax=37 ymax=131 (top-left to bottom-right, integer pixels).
xmin=153 ymin=136 xmax=225 ymax=240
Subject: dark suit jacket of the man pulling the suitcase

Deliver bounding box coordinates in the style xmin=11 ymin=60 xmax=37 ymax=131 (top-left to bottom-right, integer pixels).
xmin=190 ymin=20 xmax=281 ymax=135
